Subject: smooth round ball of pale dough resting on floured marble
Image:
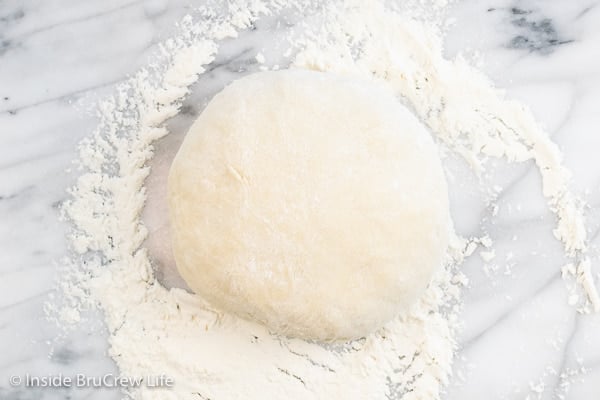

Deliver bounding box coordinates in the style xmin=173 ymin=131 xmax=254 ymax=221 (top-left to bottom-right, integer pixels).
xmin=168 ymin=70 xmax=449 ymax=341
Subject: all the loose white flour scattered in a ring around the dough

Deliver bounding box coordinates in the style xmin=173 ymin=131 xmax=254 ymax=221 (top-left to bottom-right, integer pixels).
xmin=57 ymin=1 xmax=599 ymax=400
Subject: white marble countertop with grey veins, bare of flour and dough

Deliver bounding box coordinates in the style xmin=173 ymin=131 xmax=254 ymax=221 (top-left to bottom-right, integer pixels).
xmin=0 ymin=0 xmax=600 ymax=400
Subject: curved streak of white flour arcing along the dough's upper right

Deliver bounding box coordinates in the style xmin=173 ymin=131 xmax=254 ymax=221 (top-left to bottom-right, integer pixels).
xmin=295 ymin=0 xmax=600 ymax=313
